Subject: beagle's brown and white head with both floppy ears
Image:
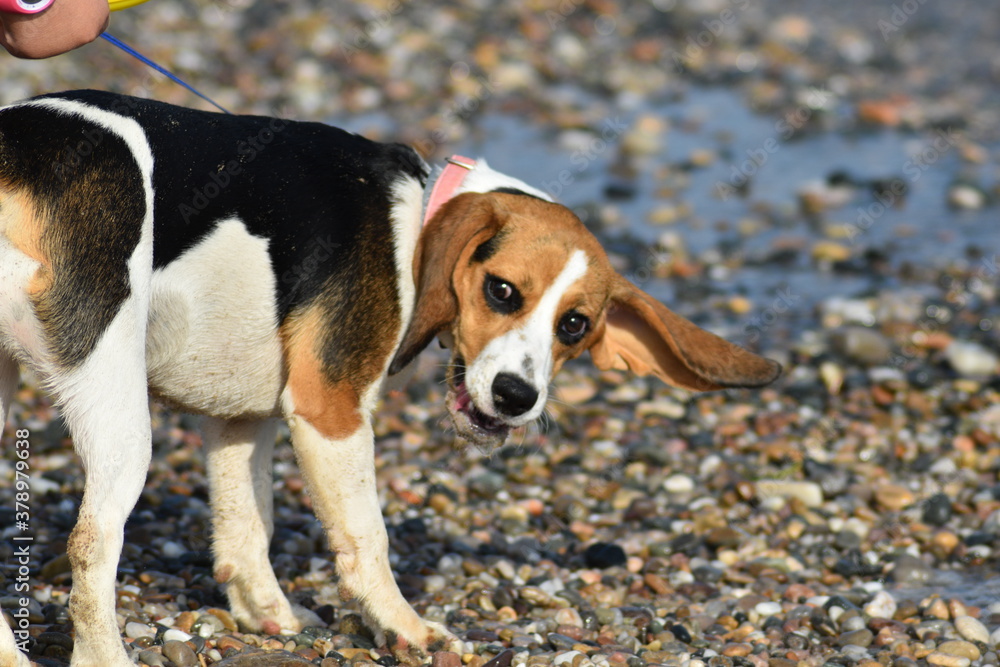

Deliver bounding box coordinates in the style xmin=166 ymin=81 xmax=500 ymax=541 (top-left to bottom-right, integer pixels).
xmin=389 ymin=185 xmax=781 ymax=447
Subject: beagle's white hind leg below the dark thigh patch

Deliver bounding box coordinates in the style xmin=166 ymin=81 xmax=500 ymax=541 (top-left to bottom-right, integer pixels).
xmin=50 ymin=297 xmax=151 ymax=667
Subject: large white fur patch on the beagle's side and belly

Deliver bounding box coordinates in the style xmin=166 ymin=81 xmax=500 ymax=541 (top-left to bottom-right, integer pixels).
xmin=146 ymin=219 xmax=284 ymax=417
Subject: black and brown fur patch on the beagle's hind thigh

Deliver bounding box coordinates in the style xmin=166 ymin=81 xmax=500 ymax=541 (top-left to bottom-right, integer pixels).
xmin=0 ymin=106 xmax=146 ymax=367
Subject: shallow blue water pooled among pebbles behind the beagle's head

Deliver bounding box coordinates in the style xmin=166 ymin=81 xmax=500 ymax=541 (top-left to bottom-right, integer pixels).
xmin=400 ymin=87 xmax=1000 ymax=308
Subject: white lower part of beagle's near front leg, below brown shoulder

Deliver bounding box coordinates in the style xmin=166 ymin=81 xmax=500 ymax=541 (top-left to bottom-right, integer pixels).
xmin=289 ymin=415 xmax=454 ymax=660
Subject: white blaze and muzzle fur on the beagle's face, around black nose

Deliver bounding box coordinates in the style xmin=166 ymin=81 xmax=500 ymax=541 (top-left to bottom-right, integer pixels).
xmin=465 ymin=250 xmax=587 ymax=426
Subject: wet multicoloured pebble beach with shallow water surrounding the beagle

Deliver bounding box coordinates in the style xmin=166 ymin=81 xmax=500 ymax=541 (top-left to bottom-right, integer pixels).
xmin=0 ymin=0 xmax=1000 ymax=667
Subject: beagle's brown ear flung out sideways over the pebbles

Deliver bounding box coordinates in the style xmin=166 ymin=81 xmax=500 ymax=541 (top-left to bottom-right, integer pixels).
xmin=590 ymin=276 xmax=781 ymax=391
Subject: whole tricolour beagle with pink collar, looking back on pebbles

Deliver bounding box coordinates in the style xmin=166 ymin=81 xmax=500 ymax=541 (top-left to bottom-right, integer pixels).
xmin=0 ymin=91 xmax=780 ymax=667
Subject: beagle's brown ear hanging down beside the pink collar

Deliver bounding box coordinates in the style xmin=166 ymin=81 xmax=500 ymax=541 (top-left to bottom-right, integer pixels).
xmin=389 ymin=192 xmax=502 ymax=375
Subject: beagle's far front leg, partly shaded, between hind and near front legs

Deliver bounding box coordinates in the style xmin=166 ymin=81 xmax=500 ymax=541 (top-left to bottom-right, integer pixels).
xmin=203 ymin=419 xmax=323 ymax=634
